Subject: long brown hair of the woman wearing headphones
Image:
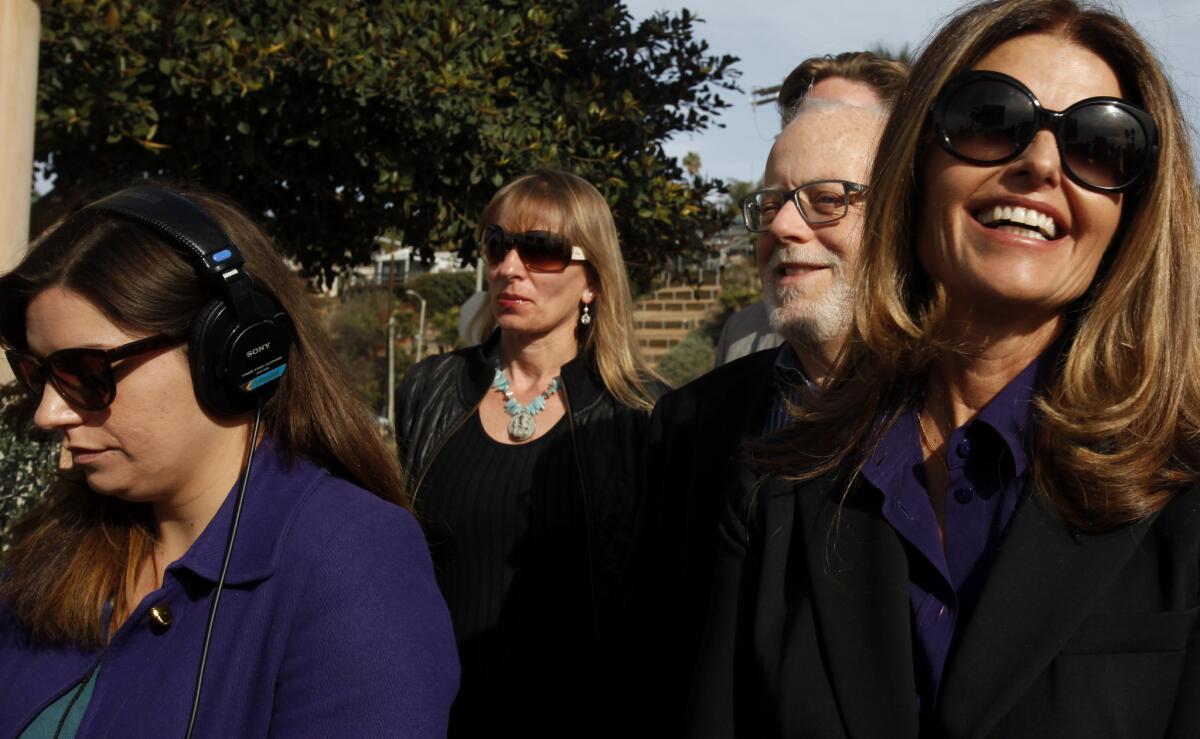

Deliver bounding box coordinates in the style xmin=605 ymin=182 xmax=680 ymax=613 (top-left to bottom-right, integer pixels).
xmin=0 ymin=184 xmax=408 ymax=645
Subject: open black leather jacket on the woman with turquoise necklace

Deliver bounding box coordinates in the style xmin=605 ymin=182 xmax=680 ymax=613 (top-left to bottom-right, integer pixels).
xmin=396 ymin=331 xmax=662 ymax=638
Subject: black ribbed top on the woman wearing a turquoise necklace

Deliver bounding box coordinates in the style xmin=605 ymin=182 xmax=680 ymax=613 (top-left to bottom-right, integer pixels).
xmin=420 ymin=413 xmax=592 ymax=737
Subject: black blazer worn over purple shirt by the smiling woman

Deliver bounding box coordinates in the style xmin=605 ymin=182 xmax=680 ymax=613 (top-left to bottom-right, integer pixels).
xmin=690 ymin=475 xmax=1200 ymax=739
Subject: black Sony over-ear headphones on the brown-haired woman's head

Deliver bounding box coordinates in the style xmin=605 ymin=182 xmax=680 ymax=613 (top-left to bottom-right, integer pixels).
xmin=88 ymin=187 xmax=294 ymax=414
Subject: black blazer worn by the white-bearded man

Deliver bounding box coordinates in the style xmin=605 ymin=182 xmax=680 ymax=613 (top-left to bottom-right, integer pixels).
xmin=637 ymin=348 xmax=779 ymax=737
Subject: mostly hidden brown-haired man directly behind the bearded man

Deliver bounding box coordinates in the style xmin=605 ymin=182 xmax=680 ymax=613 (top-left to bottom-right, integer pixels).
xmin=714 ymin=52 xmax=908 ymax=367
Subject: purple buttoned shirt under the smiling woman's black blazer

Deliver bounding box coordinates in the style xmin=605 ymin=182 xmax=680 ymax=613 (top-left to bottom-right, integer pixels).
xmin=863 ymin=353 xmax=1052 ymax=716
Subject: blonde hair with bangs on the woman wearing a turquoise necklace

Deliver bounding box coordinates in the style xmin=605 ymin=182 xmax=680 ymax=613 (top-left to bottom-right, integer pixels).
xmin=478 ymin=168 xmax=658 ymax=410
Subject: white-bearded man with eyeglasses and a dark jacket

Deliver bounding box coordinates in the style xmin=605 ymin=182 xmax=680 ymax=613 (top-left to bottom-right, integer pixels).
xmin=642 ymin=50 xmax=902 ymax=721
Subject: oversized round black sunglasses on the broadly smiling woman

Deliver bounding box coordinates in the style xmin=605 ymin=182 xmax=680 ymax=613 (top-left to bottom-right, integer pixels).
xmin=934 ymin=71 xmax=1158 ymax=192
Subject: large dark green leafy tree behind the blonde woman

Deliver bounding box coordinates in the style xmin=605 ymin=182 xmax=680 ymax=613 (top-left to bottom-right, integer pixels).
xmin=36 ymin=0 xmax=737 ymax=285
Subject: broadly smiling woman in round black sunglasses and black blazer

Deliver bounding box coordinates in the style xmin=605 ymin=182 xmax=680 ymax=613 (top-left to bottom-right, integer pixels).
xmin=692 ymin=0 xmax=1200 ymax=738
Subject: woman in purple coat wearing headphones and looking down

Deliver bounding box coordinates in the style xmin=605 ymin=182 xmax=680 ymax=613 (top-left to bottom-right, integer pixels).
xmin=0 ymin=187 xmax=458 ymax=737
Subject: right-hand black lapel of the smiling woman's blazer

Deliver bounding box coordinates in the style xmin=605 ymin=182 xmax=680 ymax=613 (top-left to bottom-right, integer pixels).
xmin=937 ymin=486 xmax=1153 ymax=737
